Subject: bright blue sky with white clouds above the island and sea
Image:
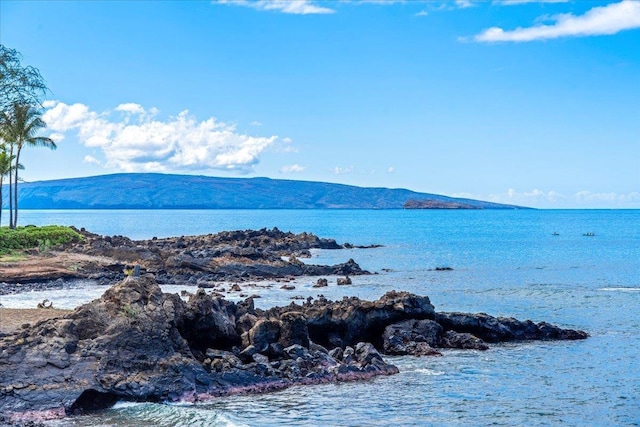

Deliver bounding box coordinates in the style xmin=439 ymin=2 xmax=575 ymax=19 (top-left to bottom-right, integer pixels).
xmin=0 ymin=0 xmax=640 ymax=209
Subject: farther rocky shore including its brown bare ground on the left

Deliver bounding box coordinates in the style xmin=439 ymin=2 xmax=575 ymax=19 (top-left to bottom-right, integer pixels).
xmin=0 ymin=228 xmax=379 ymax=295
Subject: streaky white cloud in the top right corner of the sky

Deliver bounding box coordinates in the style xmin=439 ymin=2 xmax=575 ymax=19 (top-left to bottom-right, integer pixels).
xmin=474 ymin=0 xmax=640 ymax=42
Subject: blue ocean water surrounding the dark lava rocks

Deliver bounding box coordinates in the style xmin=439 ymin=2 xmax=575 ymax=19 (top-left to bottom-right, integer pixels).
xmin=12 ymin=210 xmax=640 ymax=426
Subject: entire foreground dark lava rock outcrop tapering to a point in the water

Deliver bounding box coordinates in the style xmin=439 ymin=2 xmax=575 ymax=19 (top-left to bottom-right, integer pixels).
xmin=0 ymin=274 xmax=588 ymax=422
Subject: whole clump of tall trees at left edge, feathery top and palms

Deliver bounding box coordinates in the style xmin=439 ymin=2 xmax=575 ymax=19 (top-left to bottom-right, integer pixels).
xmin=0 ymin=44 xmax=56 ymax=228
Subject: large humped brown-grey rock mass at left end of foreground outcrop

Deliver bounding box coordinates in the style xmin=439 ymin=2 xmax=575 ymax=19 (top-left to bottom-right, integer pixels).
xmin=0 ymin=277 xmax=202 ymax=419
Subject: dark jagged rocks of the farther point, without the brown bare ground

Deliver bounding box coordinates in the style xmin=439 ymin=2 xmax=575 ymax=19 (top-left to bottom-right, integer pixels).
xmin=55 ymin=228 xmax=368 ymax=292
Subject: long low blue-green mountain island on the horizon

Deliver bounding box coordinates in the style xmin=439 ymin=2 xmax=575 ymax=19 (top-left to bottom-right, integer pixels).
xmin=5 ymin=173 xmax=518 ymax=209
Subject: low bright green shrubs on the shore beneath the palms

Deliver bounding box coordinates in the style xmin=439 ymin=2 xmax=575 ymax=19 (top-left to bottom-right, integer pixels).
xmin=0 ymin=225 xmax=83 ymax=255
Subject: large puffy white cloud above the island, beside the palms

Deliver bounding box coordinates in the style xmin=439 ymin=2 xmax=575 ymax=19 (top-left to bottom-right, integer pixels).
xmin=43 ymin=101 xmax=277 ymax=172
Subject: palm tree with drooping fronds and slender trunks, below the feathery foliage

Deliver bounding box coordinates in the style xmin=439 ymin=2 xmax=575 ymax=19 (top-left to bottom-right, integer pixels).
xmin=1 ymin=102 xmax=57 ymax=228
